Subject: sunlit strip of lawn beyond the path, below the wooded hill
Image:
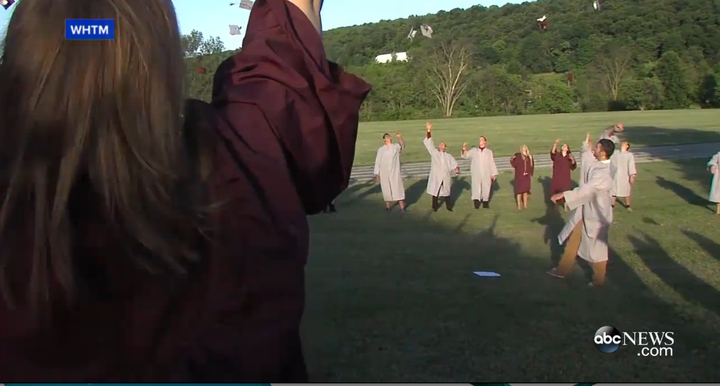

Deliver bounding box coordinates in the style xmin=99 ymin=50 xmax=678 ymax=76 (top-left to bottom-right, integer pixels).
xmin=355 ymin=110 xmax=720 ymax=166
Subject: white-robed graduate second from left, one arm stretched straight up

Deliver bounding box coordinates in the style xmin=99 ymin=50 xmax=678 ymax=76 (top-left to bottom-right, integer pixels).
xmin=423 ymin=122 xmax=460 ymax=212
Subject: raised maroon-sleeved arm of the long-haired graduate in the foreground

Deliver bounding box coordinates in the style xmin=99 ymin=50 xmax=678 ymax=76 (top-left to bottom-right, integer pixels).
xmin=212 ymin=0 xmax=370 ymax=214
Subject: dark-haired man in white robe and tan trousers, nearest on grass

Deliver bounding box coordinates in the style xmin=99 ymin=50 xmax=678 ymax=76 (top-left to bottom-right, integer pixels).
xmin=548 ymin=138 xmax=615 ymax=286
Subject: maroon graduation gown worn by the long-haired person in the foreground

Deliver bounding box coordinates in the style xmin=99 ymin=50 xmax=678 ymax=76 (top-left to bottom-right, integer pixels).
xmin=0 ymin=0 xmax=369 ymax=382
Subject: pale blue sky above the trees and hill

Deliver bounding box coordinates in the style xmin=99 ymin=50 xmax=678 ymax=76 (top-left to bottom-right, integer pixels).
xmin=0 ymin=0 xmax=518 ymax=49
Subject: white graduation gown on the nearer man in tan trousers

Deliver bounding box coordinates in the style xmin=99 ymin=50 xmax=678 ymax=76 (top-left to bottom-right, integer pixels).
xmin=558 ymin=160 xmax=613 ymax=263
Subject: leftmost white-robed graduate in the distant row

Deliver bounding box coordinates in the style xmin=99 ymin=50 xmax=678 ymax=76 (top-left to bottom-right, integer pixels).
xmin=373 ymin=133 xmax=405 ymax=212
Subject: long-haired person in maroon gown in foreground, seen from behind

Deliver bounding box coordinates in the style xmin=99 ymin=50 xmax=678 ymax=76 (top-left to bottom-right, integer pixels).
xmin=0 ymin=0 xmax=370 ymax=383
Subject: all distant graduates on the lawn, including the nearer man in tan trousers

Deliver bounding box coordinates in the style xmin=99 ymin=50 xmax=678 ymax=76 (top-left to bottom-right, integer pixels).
xmin=374 ymin=122 xmax=720 ymax=287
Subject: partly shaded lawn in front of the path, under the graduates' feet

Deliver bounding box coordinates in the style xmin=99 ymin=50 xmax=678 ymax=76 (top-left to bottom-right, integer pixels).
xmin=303 ymin=159 xmax=720 ymax=383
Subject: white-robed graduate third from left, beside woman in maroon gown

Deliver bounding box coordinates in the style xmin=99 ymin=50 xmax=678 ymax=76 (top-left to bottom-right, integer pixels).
xmin=461 ymin=137 xmax=498 ymax=209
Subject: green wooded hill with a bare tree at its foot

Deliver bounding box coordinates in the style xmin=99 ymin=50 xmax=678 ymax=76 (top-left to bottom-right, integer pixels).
xmin=187 ymin=0 xmax=720 ymax=120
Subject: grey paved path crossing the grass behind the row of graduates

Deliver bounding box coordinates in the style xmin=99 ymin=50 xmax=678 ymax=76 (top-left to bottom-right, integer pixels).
xmin=350 ymin=142 xmax=720 ymax=185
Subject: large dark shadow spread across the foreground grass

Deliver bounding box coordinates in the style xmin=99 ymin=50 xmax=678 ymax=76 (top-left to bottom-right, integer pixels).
xmin=303 ymin=188 xmax=720 ymax=382
